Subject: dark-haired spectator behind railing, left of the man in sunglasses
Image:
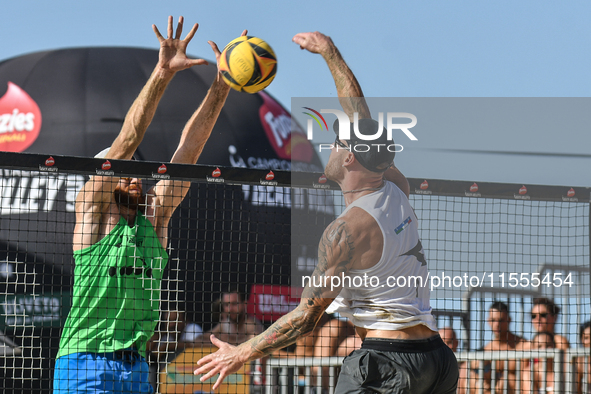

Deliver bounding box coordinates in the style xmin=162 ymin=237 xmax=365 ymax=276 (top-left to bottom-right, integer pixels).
xmin=470 ymin=301 xmax=527 ymax=394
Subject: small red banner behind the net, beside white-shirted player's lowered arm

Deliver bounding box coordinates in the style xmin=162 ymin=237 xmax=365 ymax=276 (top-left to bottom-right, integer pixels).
xmin=247 ymin=285 xmax=300 ymax=322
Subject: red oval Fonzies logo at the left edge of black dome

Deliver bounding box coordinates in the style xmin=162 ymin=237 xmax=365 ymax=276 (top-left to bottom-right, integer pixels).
xmin=0 ymin=82 xmax=41 ymax=152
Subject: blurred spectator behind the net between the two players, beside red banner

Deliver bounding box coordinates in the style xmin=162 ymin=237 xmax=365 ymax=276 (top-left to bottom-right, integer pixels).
xmin=196 ymin=285 xmax=265 ymax=345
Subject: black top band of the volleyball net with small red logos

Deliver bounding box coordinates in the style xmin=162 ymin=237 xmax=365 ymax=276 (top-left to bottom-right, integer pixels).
xmin=0 ymin=152 xmax=591 ymax=202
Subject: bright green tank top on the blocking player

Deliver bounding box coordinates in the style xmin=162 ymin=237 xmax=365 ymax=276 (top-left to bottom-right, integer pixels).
xmin=57 ymin=212 xmax=168 ymax=357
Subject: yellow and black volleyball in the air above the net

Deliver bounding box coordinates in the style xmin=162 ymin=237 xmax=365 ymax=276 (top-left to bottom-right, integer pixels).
xmin=219 ymin=36 xmax=277 ymax=93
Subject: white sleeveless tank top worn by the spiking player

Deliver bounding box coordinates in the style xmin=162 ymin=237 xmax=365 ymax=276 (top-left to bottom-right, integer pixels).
xmin=327 ymin=182 xmax=437 ymax=331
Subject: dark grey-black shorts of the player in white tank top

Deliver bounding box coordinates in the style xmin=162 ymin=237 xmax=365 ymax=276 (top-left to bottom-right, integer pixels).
xmin=335 ymin=335 xmax=459 ymax=394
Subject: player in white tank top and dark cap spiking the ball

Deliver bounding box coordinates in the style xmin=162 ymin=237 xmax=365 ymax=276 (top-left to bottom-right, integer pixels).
xmin=195 ymin=32 xmax=459 ymax=394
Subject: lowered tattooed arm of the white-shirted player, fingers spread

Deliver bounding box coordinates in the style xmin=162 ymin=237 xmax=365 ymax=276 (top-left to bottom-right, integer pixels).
xmin=195 ymin=219 xmax=355 ymax=390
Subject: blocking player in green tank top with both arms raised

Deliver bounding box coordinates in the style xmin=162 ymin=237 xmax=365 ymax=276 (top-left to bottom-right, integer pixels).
xmin=54 ymin=16 xmax=246 ymax=393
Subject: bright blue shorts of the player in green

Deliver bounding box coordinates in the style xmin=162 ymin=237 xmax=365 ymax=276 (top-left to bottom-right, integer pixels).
xmin=53 ymin=349 xmax=154 ymax=394
